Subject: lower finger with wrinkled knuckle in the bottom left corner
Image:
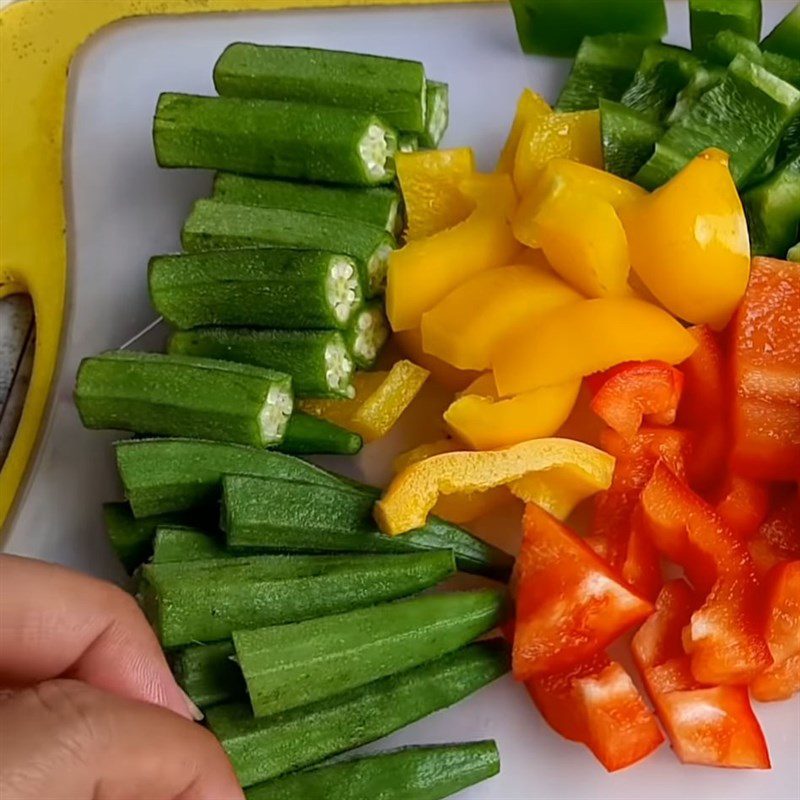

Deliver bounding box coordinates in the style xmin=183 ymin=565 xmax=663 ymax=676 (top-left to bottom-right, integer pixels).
xmin=0 ymin=680 xmax=244 ymax=800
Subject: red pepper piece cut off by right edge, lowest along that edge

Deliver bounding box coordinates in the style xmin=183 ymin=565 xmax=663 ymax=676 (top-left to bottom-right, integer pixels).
xmin=750 ymin=561 xmax=800 ymax=701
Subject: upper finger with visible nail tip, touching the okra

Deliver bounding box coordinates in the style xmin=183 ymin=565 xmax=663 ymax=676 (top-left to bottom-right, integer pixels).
xmin=0 ymin=556 xmax=193 ymax=718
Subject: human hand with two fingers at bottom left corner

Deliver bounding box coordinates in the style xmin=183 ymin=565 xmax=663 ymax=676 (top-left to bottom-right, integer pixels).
xmin=0 ymin=556 xmax=244 ymax=800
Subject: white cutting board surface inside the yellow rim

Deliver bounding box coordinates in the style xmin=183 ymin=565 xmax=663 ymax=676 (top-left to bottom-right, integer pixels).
xmin=6 ymin=0 xmax=800 ymax=800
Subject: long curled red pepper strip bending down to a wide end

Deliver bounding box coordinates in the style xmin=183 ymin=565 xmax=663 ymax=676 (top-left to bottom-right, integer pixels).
xmin=641 ymin=463 xmax=772 ymax=684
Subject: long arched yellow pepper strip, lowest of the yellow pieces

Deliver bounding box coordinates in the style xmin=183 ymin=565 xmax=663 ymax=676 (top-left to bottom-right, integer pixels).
xmin=375 ymin=439 xmax=614 ymax=536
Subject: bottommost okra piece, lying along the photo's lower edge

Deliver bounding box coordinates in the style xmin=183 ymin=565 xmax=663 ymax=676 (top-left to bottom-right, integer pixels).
xmin=245 ymin=742 xmax=500 ymax=800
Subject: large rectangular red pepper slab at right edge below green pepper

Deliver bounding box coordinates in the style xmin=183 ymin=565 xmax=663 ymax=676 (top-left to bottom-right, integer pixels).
xmin=731 ymin=258 xmax=800 ymax=481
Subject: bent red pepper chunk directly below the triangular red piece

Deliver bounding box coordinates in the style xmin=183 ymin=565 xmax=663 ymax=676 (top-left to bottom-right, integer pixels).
xmin=525 ymin=652 xmax=664 ymax=772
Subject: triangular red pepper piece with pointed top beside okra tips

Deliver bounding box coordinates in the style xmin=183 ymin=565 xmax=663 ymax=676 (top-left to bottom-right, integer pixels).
xmin=513 ymin=503 xmax=652 ymax=681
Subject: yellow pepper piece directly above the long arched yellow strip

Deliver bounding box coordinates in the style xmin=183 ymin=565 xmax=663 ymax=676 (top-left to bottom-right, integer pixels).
xmin=444 ymin=373 xmax=581 ymax=450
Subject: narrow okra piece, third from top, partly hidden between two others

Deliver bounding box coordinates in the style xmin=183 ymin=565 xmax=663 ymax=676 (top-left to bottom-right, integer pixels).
xmin=213 ymin=173 xmax=404 ymax=234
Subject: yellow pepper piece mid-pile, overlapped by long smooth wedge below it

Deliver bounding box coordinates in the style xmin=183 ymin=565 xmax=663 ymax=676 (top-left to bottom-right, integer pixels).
xmin=422 ymin=264 xmax=582 ymax=370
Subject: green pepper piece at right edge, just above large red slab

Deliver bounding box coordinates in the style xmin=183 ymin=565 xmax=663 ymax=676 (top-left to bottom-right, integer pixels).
xmin=742 ymin=153 xmax=800 ymax=258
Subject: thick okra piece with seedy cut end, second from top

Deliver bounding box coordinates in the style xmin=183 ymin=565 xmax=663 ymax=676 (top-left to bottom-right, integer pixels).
xmin=153 ymin=92 xmax=397 ymax=186
